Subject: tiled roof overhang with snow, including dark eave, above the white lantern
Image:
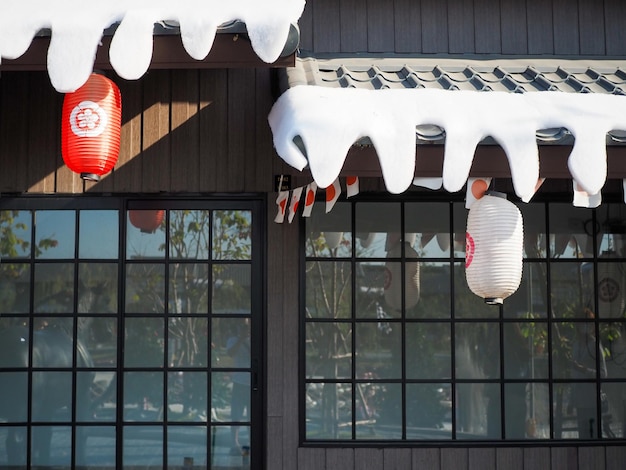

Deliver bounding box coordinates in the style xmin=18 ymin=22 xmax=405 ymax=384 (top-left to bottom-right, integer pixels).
xmin=269 ymin=57 xmax=626 ymax=201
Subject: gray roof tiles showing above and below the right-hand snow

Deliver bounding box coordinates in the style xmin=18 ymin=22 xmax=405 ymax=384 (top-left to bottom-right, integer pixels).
xmin=287 ymin=56 xmax=626 ymax=145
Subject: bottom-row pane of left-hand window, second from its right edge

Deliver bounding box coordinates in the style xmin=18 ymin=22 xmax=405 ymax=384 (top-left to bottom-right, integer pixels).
xmin=167 ymin=426 xmax=208 ymax=469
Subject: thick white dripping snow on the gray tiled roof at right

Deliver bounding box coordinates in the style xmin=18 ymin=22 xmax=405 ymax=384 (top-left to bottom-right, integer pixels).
xmin=269 ymin=85 xmax=626 ymax=201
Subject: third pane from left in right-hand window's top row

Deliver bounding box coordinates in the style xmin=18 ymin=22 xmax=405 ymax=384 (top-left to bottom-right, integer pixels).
xmin=404 ymin=202 xmax=451 ymax=258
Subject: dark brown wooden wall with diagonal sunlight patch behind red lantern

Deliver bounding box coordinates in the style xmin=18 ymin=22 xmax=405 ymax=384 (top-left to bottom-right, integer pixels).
xmin=0 ymin=69 xmax=294 ymax=194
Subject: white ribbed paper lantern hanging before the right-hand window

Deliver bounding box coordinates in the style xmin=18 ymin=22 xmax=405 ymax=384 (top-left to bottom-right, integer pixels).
xmin=465 ymin=195 xmax=524 ymax=304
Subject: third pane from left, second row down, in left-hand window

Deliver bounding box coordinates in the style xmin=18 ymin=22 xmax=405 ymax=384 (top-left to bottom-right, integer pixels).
xmin=78 ymin=263 xmax=118 ymax=313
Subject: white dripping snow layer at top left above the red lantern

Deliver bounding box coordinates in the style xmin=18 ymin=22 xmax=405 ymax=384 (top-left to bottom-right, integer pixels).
xmin=0 ymin=0 xmax=305 ymax=92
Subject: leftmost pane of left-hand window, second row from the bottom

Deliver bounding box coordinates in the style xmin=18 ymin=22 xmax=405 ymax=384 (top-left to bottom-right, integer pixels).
xmin=0 ymin=372 xmax=28 ymax=423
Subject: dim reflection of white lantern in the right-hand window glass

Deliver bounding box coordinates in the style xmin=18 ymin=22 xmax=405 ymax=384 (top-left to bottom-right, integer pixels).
xmin=384 ymin=243 xmax=420 ymax=311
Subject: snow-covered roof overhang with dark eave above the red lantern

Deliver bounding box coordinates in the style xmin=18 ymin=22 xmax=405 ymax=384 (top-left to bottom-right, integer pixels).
xmin=0 ymin=0 xmax=304 ymax=93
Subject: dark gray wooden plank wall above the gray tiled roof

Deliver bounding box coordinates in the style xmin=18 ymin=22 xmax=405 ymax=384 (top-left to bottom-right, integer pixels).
xmin=299 ymin=0 xmax=626 ymax=56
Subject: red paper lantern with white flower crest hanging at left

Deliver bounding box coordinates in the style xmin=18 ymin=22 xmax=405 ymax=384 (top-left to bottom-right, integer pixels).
xmin=61 ymin=73 xmax=122 ymax=181
